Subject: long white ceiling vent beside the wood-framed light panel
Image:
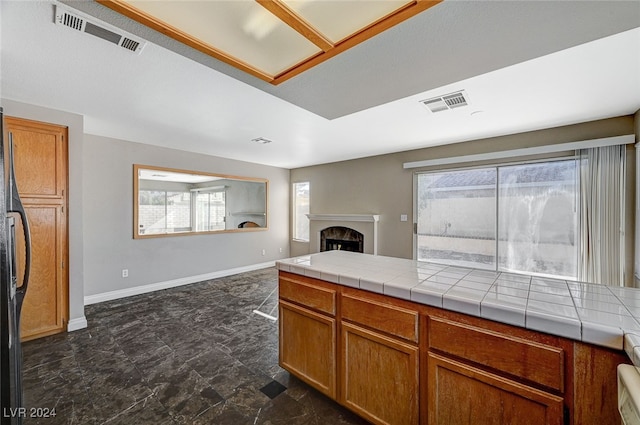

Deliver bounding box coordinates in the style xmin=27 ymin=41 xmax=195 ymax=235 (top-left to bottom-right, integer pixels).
xmin=56 ymin=6 xmax=146 ymax=53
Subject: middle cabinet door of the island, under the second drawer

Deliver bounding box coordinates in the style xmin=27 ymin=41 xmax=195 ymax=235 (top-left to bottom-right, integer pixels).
xmin=340 ymin=322 xmax=419 ymax=425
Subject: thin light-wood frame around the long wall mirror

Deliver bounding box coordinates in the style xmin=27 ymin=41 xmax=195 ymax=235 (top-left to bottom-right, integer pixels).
xmin=133 ymin=164 xmax=269 ymax=239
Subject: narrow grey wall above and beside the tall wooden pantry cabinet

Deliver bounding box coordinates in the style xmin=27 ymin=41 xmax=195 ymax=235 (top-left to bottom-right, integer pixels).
xmin=1 ymin=99 xmax=85 ymax=322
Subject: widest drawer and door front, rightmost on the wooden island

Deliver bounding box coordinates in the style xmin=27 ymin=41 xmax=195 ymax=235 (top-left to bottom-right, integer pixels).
xmin=426 ymin=313 xmax=571 ymax=425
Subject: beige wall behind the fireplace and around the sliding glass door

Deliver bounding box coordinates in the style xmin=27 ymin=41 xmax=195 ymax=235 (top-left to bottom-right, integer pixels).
xmin=291 ymin=114 xmax=639 ymax=284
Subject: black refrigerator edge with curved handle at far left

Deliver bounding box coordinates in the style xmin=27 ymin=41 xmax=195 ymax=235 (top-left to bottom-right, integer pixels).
xmin=0 ymin=107 xmax=31 ymax=425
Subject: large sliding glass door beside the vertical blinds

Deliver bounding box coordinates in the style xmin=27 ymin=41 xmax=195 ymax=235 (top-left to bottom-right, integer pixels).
xmin=416 ymin=160 xmax=579 ymax=278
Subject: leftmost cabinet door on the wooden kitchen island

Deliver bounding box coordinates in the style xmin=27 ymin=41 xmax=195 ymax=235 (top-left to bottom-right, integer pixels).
xmin=278 ymin=300 xmax=336 ymax=400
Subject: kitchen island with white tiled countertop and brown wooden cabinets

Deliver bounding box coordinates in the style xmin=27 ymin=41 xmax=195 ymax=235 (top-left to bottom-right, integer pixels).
xmin=277 ymin=251 xmax=640 ymax=425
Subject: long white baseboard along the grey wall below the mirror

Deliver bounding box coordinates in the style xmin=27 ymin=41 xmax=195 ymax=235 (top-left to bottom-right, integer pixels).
xmin=84 ymin=261 xmax=276 ymax=304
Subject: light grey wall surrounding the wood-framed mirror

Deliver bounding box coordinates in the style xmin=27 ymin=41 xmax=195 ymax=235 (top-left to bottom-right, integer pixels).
xmin=82 ymin=134 xmax=289 ymax=298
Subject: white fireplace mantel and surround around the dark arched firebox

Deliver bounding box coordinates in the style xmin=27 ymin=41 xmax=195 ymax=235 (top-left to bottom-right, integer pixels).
xmin=307 ymin=214 xmax=380 ymax=255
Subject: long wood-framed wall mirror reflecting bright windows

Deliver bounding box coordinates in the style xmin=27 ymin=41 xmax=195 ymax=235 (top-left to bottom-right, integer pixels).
xmin=133 ymin=164 xmax=268 ymax=239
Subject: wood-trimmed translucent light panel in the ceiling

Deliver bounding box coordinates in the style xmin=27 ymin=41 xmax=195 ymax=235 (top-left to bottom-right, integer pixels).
xmin=97 ymin=0 xmax=442 ymax=85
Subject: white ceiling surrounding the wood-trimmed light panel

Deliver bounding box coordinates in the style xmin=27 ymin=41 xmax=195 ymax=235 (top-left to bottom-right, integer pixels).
xmin=0 ymin=0 xmax=640 ymax=168
